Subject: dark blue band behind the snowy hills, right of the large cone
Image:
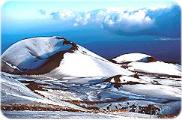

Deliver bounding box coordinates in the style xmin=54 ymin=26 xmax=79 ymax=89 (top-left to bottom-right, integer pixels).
xmin=82 ymin=40 xmax=181 ymax=64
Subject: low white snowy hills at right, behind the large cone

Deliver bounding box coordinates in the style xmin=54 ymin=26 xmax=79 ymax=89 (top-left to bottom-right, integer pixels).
xmin=113 ymin=53 xmax=182 ymax=77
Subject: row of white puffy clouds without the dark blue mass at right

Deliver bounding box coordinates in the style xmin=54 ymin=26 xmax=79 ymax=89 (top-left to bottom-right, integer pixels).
xmin=50 ymin=9 xmax=152 ymax=29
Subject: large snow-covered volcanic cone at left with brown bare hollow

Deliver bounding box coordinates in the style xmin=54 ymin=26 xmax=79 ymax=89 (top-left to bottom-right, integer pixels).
xmin=1 ymin=37 xmax=133 ymax=78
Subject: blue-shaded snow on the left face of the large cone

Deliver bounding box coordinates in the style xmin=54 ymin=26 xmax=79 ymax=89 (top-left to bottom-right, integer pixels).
xmin=2 ymin=37 xmax=71 ymax=70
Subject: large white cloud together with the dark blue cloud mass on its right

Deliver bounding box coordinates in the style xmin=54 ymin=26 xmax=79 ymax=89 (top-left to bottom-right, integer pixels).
xmin=104 ymin=6 xmax=181 ymax=37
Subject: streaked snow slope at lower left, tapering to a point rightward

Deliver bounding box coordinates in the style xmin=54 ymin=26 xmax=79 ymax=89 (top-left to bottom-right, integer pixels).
xmin=0 ymin=75 xmax=85 ymax=110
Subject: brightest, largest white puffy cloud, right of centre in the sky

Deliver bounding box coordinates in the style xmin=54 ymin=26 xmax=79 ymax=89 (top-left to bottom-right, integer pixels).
xmin=104 ymin=10 xmax=154 ymax=32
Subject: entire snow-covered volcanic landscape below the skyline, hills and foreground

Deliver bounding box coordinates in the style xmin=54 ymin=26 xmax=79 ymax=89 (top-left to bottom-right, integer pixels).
xmin=1 ymin=36 xmax=182 ymax=118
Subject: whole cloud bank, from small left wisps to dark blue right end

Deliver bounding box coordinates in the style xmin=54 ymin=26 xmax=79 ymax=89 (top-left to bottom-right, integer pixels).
xmin=39 ymin=5 xmax=181 ymax=38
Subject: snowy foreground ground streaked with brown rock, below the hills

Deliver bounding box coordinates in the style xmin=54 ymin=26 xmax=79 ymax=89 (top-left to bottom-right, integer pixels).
xmin=1 ymin=70 xmax=182 ymax=118
